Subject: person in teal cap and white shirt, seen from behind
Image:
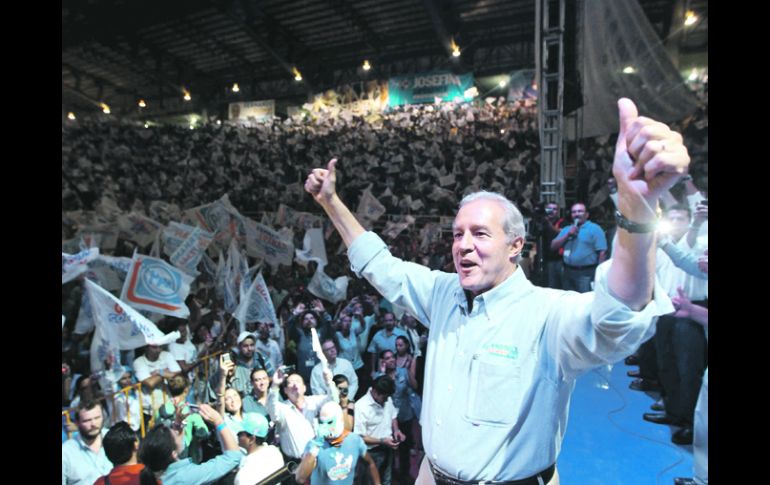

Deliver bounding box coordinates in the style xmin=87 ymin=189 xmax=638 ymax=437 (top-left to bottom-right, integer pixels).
xmin=234 ymin=413 xmax=284 ymax=485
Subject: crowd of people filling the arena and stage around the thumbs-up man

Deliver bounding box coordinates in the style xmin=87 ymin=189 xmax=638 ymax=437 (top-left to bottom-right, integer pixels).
xmin=62 ymin=81 xmax=708 ymax=485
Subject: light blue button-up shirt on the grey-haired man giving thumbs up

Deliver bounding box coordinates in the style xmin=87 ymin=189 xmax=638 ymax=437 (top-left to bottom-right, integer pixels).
xmin=348 ymin=232 xmax=674 ymax=480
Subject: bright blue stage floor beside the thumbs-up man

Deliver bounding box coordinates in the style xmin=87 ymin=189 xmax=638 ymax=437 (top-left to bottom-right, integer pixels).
xmin=557 ymin=361 xmax=692 ymax=485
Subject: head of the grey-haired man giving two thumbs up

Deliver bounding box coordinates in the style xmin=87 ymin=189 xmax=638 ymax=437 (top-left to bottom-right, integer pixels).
xmin=452 ymin=199 xmax=524 ymax=295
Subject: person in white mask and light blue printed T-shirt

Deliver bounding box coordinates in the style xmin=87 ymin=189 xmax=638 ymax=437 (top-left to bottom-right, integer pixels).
xmin=294 ymin=401 xmax=380 ymax=485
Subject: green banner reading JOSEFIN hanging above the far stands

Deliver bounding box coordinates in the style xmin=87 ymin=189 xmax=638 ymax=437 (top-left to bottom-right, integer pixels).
xmin=388 ymin=71 xmax=473 ymax=106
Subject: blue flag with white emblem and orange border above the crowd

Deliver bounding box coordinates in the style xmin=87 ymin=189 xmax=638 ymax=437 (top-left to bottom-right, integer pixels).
xmin=120 ymin=254 xmax=194 ymax=318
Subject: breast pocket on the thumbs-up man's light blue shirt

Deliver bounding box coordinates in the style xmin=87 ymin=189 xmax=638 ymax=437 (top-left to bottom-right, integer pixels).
xmin=465 ymin=355 xmax=524 ymax=426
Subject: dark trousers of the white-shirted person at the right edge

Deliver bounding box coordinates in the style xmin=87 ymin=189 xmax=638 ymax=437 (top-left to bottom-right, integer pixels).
xmin=655 ymin=315 xmax=708 ymax=426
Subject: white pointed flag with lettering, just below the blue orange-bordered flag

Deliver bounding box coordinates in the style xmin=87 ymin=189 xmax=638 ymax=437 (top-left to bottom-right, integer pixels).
xmin=85 ymin=280 xmax=179 ymax=374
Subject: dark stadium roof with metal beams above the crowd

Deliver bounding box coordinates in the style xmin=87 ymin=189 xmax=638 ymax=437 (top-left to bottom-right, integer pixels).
xmin=62 ymin=0 xmax=708 ymax=118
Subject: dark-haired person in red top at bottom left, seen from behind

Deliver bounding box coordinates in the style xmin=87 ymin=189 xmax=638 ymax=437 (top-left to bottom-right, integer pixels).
xmin=94 ymin=422 xmax=144 ymax=485
